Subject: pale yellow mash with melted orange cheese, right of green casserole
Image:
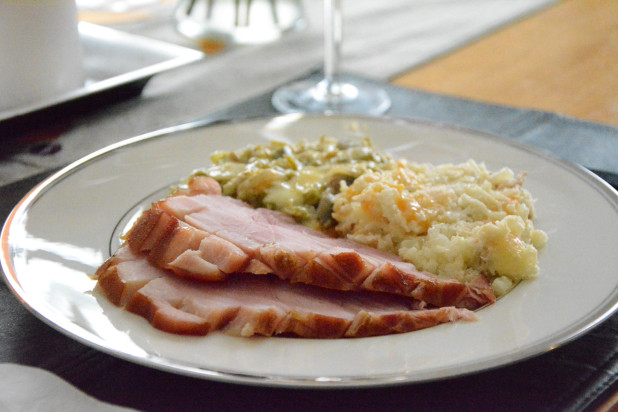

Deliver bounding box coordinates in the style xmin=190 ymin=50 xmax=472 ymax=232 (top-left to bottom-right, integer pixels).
xmin=333 ymin=160 xmax=547 ymax=296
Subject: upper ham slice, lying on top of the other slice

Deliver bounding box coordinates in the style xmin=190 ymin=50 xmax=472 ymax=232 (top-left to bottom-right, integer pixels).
xmin=122 ymin=192 xmax=495 ymax=310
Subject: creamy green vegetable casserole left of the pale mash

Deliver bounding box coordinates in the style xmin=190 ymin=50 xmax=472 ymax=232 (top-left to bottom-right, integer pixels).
xmin=196 ymin=137 xmax=394 ymax=230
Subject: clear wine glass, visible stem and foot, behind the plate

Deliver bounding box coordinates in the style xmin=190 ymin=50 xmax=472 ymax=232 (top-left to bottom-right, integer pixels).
xmin=272 ymin=0 xmax=391 ymax=114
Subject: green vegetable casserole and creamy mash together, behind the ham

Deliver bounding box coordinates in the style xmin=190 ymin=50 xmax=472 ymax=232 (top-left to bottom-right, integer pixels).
xmin=195 ymin=137 xmax=547 ymax=296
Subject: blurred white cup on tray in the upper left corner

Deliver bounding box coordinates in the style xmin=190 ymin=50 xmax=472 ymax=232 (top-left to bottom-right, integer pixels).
xmin=0 ymin=0 xmax=84 ymax=111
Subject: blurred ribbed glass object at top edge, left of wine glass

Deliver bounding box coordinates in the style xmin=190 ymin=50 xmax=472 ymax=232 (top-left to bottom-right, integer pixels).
xmin=174 ymin=0 xmax=306 ymax=44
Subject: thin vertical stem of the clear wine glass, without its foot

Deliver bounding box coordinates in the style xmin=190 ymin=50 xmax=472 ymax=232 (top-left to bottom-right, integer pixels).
xmin=324 ymin=0 xmax=343 ymax=98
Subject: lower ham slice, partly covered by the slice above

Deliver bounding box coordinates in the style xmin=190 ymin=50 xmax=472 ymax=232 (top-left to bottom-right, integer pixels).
xmin=97 ymin=246 xmax=476 ymax=338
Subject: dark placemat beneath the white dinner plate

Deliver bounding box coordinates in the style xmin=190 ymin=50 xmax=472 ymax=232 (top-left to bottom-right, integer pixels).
xmin=0 ymin=75 xmax=618 ymax=411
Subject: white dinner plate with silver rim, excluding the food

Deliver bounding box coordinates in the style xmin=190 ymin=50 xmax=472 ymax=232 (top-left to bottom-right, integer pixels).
xmin=1 ymin=114 xmax=618 ymax=387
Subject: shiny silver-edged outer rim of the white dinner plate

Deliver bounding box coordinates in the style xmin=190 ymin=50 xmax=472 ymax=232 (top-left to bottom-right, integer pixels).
xmin=0 ymin=113 xmax=618 ymax=388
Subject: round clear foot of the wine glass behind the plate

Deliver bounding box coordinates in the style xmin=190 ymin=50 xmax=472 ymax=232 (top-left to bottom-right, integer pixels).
xmin=272 ymin=77 xmax=391 ymax=114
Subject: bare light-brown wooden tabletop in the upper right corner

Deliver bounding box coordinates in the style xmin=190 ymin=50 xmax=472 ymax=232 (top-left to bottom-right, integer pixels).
xmin=392 ymin=0 xmax=618 ymax=125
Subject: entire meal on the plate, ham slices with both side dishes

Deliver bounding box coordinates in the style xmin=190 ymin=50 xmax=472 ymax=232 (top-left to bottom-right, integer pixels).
xmin=95 ymin=137 xmax=546 ymax=338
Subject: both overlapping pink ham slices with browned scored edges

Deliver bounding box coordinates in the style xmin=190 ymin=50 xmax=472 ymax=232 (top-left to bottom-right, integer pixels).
xmin=95 ymin=178 xmax=495 ymax=338
